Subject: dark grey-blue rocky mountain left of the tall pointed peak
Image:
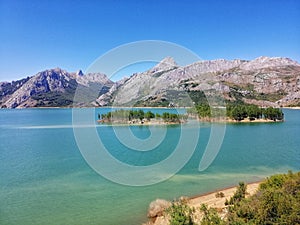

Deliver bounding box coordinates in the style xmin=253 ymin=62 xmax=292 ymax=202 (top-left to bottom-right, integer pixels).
xmin=0 ymin=68 xmax=113 ymax=108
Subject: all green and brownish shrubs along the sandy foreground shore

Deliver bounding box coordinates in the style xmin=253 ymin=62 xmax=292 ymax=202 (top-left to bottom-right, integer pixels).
xmin=166 ymin=172 xmax=300 ymax=225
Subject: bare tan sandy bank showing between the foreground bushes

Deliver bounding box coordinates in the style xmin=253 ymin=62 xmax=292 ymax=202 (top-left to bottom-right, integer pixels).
xmin=151 ymin=181 xmax=261 ymax=225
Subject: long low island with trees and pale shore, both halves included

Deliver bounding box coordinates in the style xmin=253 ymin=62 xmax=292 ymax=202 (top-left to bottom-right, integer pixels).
xmin=97 ymin=103 xmax=284 ymax=125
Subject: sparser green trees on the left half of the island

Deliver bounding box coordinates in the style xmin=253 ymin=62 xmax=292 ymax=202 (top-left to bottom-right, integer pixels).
xmin=98 ymin=109 xmax=187 ymax=123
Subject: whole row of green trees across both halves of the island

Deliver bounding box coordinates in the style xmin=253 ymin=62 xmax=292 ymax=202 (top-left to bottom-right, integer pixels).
xmin=98 ymin=103 xmax=284 ymax=123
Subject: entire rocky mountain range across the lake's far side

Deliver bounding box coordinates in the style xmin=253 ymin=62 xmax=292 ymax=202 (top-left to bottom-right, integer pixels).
xmin=0 ymin=57 xmax=300 ymax=108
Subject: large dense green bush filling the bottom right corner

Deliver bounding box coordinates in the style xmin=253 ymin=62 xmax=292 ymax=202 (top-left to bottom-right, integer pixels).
xmin=227 ymin=172 xmax=300 ymax=225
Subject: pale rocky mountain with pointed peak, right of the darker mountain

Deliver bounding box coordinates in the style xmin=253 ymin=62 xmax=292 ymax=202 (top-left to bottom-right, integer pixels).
xmin=97 ymin=57 xmax=300 ymax=106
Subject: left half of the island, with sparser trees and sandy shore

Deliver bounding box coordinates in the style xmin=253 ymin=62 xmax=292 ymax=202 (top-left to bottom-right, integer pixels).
xmin=97 ymin=109 xmax=188 ymax=125
